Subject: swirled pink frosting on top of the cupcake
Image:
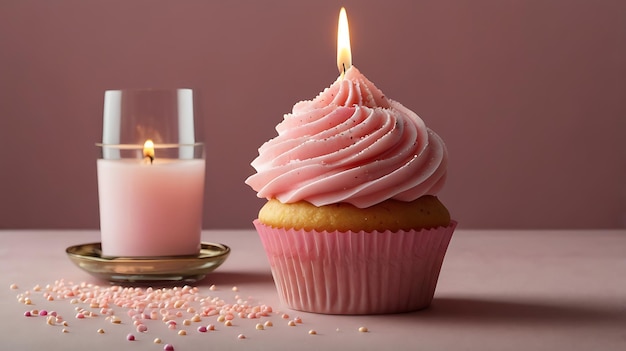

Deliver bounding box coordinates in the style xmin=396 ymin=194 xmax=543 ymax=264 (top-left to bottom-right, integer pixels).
xmin=246 ymin=66 xmax=448 ymax=208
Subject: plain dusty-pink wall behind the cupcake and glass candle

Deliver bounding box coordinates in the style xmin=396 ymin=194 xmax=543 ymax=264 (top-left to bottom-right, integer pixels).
xmin=0 ymin=0 xmax=626 ymax=228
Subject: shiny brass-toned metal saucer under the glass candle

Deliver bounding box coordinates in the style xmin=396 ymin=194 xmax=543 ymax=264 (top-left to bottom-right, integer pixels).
xmin=65 ymin=243 xmax=230 ymax=283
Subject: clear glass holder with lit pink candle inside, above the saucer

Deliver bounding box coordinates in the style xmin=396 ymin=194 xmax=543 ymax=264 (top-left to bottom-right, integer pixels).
xmin=97 ymin=89 xmax=205 ymax=257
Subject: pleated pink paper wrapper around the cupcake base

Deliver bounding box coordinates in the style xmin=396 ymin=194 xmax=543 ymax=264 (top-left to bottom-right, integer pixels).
xmin=254 ymin=220 xmax=457 ymax=314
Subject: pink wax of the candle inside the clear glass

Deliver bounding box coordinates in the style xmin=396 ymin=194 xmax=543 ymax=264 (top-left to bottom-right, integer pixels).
xmin=97 ymin=158 xmax=205 ymax=257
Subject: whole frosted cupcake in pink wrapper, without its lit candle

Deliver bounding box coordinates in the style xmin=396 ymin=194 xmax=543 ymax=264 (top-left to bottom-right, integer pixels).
xmin=246 ymin=66 xmax=456 ymax=314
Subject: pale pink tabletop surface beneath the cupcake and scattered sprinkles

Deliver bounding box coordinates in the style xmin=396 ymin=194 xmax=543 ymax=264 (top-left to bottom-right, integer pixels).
xmin=0 ymin=230 xmax=626 ymax=351
